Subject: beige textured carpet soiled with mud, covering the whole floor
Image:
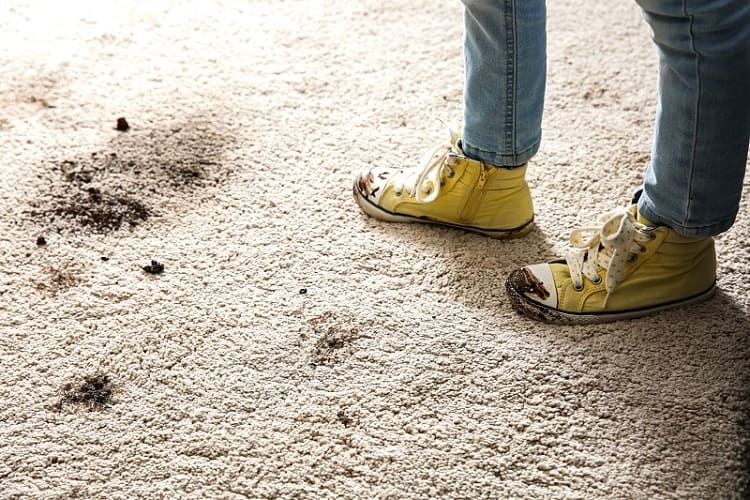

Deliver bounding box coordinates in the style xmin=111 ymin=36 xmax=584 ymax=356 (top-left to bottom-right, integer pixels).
xmin=0 ymin=0 xmax=750 ymax=499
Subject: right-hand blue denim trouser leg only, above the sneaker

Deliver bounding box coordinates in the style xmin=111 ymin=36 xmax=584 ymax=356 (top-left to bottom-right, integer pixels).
xmin=637 ymin=0 xmax=750 ymax=236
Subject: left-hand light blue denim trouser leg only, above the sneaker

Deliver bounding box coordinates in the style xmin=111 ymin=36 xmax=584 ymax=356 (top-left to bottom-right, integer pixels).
xmin=461 ymin=0 xmax=547 ymax=166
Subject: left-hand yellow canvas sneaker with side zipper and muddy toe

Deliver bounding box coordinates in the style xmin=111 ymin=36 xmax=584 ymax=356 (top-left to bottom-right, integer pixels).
xmin=354 ymin=132 xmax=534 ymax=238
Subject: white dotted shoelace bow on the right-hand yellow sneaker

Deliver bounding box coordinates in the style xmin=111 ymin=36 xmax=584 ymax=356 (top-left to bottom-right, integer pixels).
xmin=565 ymin=208 xmax=654 ymax=305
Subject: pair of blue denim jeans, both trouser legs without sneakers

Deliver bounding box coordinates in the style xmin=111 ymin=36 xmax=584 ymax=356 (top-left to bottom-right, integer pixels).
xmin=462 ymin=0 xmax=750 ymax=236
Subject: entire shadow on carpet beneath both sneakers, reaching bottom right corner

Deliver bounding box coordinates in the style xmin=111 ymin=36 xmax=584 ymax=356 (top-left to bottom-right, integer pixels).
xmin=356 ymin=215 xmax=750 ymax=497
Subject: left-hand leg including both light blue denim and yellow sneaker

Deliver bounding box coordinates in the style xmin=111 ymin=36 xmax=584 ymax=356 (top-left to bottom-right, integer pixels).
xmin=353 ymin=0 xmax=546 ymax=238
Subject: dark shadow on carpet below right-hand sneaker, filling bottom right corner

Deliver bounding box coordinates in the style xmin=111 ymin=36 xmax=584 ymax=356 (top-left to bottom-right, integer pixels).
xmin=536 ymin=291 xmax=750 ymax=492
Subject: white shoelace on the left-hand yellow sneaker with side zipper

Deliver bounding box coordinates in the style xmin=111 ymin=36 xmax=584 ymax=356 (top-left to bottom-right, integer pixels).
xmin=393 ymin=129 xmax=462 ymax=203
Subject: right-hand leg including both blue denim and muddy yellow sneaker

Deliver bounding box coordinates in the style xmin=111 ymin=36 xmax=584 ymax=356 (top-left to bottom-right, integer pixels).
xmin=506 ymin=0 xmax=750 ymax=323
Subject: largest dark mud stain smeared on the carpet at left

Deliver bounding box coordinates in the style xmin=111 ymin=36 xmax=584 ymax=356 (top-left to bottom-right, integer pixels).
xmin=24 ymin=119 xmax=232 ymax=234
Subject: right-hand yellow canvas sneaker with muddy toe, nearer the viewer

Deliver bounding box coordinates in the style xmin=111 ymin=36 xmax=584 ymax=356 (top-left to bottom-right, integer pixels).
xmin=506 ymin=206 xmax=716 ymax=324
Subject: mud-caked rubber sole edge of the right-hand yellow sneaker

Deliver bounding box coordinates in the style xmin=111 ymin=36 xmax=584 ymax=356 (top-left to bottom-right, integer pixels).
xmin=505 ymin=270 xmax=716 ymax=325
